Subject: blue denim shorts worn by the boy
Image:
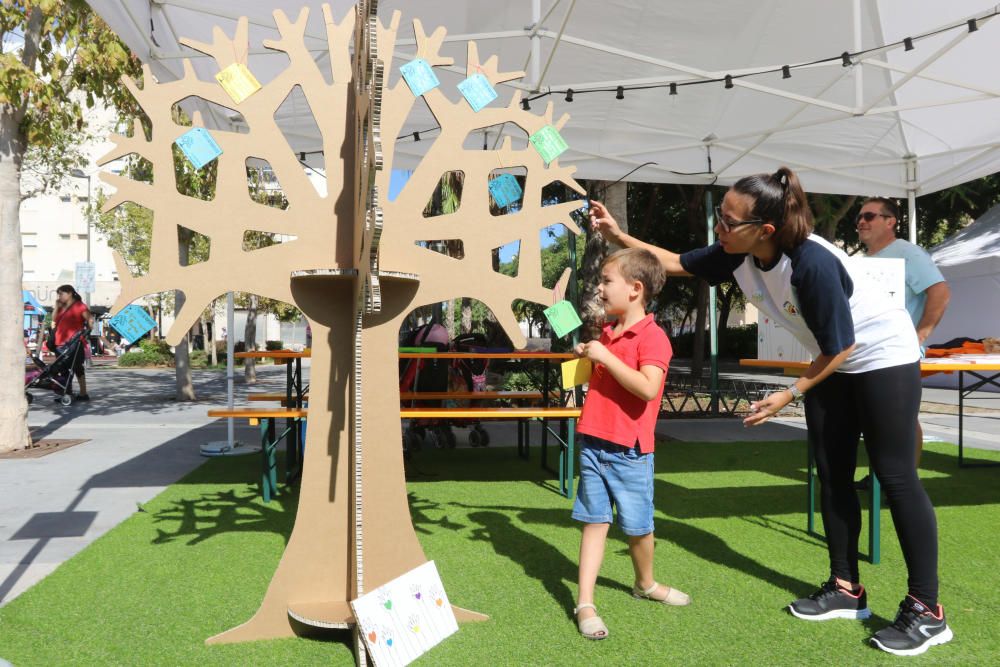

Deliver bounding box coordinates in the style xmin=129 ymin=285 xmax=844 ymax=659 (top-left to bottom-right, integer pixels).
xmin=572 ymin=435 xmax=653 ymax=535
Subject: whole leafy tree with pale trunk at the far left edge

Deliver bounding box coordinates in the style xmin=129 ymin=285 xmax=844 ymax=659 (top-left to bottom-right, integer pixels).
xmin=0 ymin=0 xmax=139 ymax=450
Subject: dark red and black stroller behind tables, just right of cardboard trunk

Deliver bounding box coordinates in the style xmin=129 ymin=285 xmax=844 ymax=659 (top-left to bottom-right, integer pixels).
xmin=399 ymin=322 xmax=456 ymax=455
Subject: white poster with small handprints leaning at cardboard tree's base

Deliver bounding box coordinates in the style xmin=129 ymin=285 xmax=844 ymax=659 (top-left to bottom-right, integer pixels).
xmin=351 ymin=561 xmax=458 ymax=666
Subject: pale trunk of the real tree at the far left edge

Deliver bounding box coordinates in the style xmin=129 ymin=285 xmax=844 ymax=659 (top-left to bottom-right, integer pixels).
xmin=0 ymin=112 xmax=31 ymax=452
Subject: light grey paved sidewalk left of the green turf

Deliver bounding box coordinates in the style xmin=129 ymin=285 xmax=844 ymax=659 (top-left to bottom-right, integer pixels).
xmin=0 ymin=365 xmax=285 ymax=605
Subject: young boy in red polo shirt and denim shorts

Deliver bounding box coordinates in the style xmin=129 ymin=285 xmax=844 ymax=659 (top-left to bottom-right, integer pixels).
xmin=572 ymin=248 xmax=691 ymax=639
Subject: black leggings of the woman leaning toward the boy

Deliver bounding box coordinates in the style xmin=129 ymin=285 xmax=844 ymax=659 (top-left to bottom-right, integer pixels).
xmin=805 ymin=363 xmax=938 ymax=609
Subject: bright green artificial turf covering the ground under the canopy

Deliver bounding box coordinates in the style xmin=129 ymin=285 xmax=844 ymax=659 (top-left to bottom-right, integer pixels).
xmin=0 ymin=442 xmax=1000 ymax=667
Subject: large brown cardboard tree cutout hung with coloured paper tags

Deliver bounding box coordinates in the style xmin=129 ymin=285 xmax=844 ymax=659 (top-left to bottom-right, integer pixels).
xmin=102 ymin=1 xmax=583 ymax=660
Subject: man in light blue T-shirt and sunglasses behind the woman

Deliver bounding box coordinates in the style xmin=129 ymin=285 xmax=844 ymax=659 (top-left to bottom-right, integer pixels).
xmin=855 ymin=197 xmax=951 ymax=465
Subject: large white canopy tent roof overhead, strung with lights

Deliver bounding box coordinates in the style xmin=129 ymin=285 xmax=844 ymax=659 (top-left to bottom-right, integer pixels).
xmin=89 ymin=0 xmax=1000 ymax=240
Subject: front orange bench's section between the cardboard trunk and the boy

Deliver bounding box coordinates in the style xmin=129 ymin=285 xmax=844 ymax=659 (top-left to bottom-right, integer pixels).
xmin=399 ymin=404 xmax=580 ymax=498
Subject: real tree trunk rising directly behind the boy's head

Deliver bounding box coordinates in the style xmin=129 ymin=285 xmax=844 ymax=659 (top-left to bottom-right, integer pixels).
xmin=577 ymin=181 xmax=628 ymax=342
